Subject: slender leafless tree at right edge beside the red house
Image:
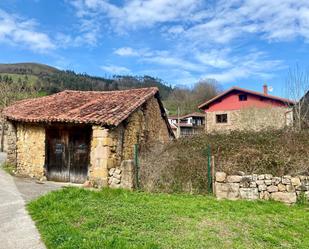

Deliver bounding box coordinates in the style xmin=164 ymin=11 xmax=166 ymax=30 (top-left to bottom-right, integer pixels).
xmin=286 ymin=65 xmax=309 ymax=130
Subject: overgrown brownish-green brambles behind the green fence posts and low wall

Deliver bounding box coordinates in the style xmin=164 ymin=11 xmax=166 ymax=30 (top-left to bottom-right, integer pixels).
xmin=141 ymin=130 xmax=309 ymax=193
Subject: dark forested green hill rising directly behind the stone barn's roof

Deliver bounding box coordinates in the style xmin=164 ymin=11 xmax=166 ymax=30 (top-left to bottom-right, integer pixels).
xmin=0 ymin=63 xmax=173 ymax=99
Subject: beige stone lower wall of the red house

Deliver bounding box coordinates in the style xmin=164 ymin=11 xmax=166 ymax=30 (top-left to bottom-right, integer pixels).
xmin=206 ymin=107 xmax=293 ymax=133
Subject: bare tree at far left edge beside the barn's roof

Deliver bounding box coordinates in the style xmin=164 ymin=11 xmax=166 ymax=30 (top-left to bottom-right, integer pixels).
xmin=0 ymin=80 xmax=38 ymax=151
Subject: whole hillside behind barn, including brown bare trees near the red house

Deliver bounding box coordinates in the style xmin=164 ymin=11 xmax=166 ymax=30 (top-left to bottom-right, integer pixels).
xmin=0 ymin=63 xmax=222 ymax=115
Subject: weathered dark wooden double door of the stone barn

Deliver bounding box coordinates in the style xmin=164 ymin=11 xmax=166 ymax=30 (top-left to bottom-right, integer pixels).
xmin=46 ymin=127 xmax=91 ymax=183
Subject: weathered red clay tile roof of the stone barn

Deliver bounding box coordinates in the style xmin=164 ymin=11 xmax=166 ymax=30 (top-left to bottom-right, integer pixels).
xmin=4 ymin=87 xmax=159 ymax=126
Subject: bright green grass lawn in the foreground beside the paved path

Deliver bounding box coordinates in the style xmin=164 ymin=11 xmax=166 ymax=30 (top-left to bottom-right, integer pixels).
xmin=28 ymin=188 xmax=309 ymax=249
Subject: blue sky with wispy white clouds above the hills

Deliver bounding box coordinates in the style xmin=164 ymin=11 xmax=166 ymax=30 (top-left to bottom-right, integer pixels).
xmin=0 ymin=0 xmax=309 ymax=96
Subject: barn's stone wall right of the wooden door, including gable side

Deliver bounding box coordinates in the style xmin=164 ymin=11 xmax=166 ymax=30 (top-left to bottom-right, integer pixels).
xmin=89 ymin=98 xmax=170 ymax=189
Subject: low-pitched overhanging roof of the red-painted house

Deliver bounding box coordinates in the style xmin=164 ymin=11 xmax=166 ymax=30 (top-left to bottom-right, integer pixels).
xmin=198 ymin=87 xmax=295 ymax=109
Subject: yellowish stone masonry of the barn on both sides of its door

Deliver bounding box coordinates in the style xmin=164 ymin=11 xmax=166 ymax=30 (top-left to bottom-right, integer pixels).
xmin=7 ymin=94 xmax=170 ymax=189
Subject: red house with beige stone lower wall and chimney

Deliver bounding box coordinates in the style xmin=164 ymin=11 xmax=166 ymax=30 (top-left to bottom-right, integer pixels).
xmin=199 ymin=85 xmax=294 ymax=132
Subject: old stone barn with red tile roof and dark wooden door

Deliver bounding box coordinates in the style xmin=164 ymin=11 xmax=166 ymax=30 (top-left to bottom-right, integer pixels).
xmin=4 ymin=88 xmax=173 ymax=187
